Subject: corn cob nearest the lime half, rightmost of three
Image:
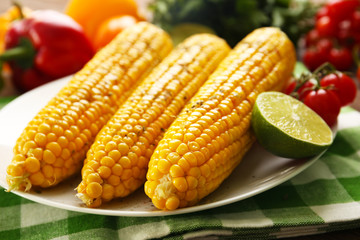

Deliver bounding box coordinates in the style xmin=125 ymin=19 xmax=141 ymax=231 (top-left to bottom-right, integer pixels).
xmin=145 ymin=28 xmax=296 ymax=210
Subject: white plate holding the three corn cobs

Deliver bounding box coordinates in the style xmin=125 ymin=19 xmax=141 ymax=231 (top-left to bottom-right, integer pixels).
xmin=0 ymin=78 xmax=330 ymax=216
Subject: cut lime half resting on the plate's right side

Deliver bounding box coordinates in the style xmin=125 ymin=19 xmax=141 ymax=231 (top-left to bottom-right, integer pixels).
xmin=251 ymin=92 xmax=333 ymax=158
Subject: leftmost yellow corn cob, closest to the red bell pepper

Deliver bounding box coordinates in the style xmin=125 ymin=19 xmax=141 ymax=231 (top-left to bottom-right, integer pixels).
xmin=7 ymin=22 xmax=172 ymax=191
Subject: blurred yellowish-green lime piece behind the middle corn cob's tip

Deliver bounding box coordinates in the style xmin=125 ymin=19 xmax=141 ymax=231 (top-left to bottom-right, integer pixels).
xmin=169 ymin=23 xmax=215 ymax=45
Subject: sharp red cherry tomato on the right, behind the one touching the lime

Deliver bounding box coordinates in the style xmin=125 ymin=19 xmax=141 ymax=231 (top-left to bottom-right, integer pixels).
xmin=320 ymin=72 xmax=357 ymax=106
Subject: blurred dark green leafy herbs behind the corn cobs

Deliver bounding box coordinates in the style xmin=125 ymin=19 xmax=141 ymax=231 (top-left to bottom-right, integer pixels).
xmin=150 ymin=0 xmax=317 ymax=46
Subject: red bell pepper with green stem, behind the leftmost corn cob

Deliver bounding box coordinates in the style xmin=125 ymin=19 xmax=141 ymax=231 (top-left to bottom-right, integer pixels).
xmin=0 ymin=7 xmax=95 ymax=92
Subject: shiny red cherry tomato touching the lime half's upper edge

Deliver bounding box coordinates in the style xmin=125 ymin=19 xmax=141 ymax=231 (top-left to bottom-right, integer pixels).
xmin=304 ymin=89 xmax=341 ymax=126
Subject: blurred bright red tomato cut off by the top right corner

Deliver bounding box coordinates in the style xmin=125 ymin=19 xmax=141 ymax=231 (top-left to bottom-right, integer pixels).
xmin=326 ymin=0 xmax=360 ymax=21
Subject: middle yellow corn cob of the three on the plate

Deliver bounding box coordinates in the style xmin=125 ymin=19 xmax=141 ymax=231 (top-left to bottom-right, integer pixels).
xmin=77 ymin=34 xmax=230 ymax=208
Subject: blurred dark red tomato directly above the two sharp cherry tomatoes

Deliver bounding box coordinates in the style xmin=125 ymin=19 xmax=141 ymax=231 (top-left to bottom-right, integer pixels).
xmin=328 ymin=47 xmax=353 ymax=71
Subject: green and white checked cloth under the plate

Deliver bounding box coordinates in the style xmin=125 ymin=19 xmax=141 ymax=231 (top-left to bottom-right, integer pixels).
xmin=0 ymin=96 xmax=360 ymax=240
